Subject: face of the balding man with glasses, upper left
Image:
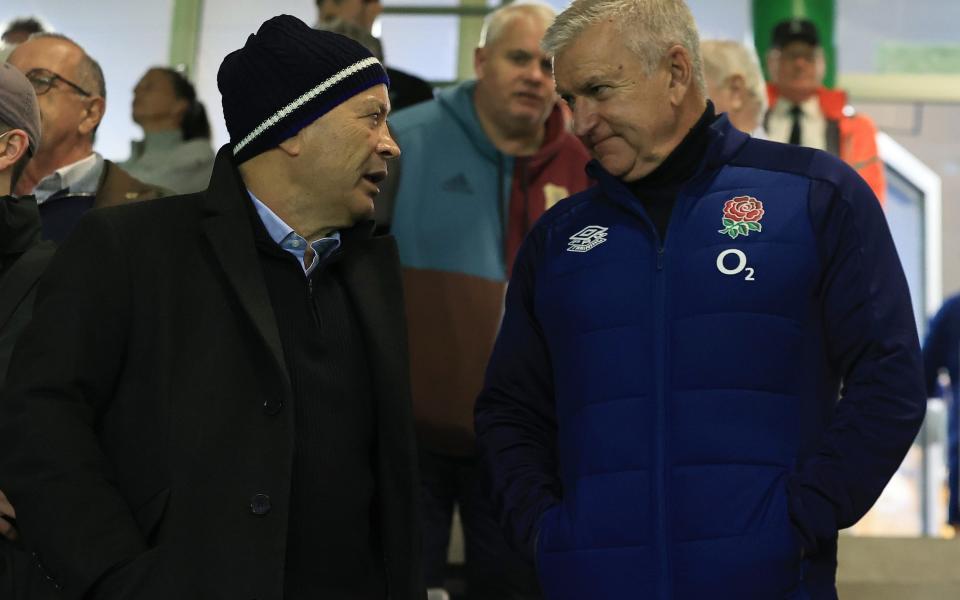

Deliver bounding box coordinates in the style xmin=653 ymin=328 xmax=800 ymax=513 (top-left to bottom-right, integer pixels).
xmin=7 ymin=38 xmax=99 ymax=164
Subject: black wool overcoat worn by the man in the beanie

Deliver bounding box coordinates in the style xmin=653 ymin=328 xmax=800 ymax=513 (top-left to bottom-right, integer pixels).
xmin=0 ymin=150 xmax=426 ymax=600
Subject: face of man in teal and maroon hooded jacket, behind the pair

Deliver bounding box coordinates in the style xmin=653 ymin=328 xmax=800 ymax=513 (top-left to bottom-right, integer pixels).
xmin=474 ymin=16 xmax=557 ymax=137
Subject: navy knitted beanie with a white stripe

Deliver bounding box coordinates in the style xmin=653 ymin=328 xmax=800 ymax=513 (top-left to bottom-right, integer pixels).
xmin=217 ymin=15 xmax=389 ymax=164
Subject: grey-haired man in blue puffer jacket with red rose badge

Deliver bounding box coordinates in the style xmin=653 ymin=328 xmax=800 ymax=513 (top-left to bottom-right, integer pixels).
xmin=475 ymin=0 xmax=925 ymax=600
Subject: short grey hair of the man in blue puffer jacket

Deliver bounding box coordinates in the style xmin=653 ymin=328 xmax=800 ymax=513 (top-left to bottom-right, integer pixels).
xmin=541 ymin=0 xmax=706 ymax=93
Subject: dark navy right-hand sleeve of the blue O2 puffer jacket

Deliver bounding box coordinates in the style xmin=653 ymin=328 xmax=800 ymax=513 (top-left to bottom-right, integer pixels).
xmin=788 ymin=158 xmax=926 ymax=554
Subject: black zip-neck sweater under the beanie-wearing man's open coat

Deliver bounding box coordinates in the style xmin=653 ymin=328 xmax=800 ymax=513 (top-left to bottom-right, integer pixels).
xmin=251 ymin=211 xmax=386 ymax=600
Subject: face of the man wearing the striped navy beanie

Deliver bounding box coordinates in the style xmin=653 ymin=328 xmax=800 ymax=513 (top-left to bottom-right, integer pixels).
xmin=293 ymin=84 xmax=400 ymax=228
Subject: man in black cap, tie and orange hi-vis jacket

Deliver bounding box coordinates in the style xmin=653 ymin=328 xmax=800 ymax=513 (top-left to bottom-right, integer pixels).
xmin=765 ymin=19 xmax=886 ymax=203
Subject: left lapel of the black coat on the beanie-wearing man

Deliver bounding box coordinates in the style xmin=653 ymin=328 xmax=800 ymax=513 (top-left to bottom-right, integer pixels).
xmin=203 ymin=146 xmax=292 ymax=395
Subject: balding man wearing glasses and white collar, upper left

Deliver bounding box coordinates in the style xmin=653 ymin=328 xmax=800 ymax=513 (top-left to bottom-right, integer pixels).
xmin=8 ymin=33 xmax=164 ymax=241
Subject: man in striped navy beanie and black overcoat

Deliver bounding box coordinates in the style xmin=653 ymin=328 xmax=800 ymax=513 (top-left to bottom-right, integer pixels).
xmin=0 ymin=16 xmax=425 ymax=600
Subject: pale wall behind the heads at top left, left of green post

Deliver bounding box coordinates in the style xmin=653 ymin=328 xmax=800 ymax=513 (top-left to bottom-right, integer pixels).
xmin=0 ymin=0 xmax=173 ymax=159
